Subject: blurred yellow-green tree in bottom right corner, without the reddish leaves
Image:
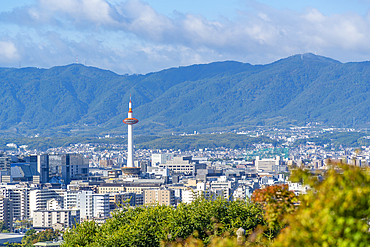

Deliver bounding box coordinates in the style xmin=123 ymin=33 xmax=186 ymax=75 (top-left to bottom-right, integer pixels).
xmin=274 ymin=164 xmax=370 ymax=247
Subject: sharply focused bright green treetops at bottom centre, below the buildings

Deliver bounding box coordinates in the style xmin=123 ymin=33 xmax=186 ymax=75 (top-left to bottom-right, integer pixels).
xmin=63 ymin=198 xmax=265 ymax=247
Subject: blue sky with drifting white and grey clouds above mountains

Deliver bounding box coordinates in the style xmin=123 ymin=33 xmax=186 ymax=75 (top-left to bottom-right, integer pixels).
xmin=0 ymin=0 xmax=370 ymax=74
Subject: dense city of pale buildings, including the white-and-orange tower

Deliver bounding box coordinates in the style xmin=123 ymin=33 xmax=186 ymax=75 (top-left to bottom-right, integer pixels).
xmin=0 ymin=100 xmax=370 ymax=245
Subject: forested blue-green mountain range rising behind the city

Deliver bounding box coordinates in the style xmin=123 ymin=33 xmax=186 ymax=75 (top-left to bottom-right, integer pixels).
xmin=0 ymin=54 xmax=370 ymax=136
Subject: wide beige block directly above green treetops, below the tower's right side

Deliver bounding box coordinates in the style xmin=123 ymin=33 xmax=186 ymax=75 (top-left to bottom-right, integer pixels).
xmin=144 ymin=189 xmax=175 ymax=205
